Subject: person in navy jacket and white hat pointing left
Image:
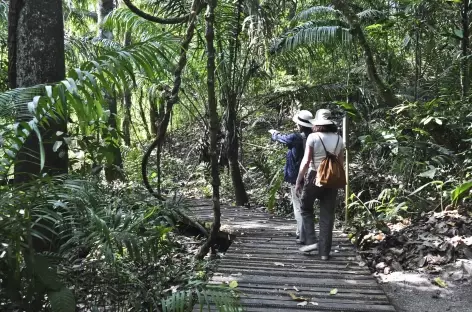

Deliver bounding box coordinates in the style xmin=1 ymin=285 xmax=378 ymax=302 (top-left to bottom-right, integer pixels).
xmin=269 ymin=110 xmax=313 ymax=242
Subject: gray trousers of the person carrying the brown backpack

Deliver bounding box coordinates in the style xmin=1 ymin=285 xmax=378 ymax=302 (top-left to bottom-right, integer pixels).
xmin=300 ymin=170 xmax=338 ymax=256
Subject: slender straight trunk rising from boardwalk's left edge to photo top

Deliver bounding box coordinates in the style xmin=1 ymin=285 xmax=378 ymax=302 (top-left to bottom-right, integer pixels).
xmin=196 ymin=0 xmax=221 ymax=259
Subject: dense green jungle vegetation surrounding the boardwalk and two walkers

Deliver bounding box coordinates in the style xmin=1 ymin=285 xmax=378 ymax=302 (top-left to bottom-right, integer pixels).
xmin=0 ymin=0 xmax=472 ymax=312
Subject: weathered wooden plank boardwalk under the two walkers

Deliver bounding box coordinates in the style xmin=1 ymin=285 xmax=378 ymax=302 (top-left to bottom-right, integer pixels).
xmin=186 ymin=201 xmax=395 ymax=312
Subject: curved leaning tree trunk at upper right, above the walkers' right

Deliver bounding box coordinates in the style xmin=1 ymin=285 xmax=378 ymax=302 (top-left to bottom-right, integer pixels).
xmin=333 ymin=0 xmax=399 ymax=106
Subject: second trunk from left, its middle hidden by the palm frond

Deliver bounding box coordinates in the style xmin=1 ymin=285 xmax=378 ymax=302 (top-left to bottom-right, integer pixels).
xmin=98 ymin=0 xmax=124 ymax=182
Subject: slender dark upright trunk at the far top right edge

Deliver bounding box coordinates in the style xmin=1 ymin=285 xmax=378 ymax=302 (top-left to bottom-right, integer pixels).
xmin=461 ymin=0 xmax=470 ymax=99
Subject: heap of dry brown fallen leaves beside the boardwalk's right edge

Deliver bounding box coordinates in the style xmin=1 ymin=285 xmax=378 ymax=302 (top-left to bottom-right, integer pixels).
xmin=360 ymin=210 xmax=472 ymax=274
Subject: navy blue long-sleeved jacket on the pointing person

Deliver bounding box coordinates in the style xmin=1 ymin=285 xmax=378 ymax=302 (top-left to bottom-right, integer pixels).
xmin=272 ymin=132 xmax=304 ymax=184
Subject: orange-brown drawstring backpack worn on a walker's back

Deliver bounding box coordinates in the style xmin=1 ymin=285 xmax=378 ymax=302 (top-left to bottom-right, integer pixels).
xmin=313 ymin=135 xmax=346 ymax=188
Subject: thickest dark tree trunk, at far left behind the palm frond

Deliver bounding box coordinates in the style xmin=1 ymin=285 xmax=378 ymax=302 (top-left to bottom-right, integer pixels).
xmin=8 ymin=0 xmax=68 ymax=182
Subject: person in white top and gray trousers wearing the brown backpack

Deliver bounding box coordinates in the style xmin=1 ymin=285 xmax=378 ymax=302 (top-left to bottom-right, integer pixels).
xmin=295 ymin=109 xmax=344 ymax=260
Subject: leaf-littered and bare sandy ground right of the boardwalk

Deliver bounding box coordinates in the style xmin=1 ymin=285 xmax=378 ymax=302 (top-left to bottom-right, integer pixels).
xmin=361 ymin=210 xmax=472 ymax=312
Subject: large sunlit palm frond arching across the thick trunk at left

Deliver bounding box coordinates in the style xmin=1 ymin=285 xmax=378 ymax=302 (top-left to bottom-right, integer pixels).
xmin=0 ymin=40 xmax=175 ymax=176
